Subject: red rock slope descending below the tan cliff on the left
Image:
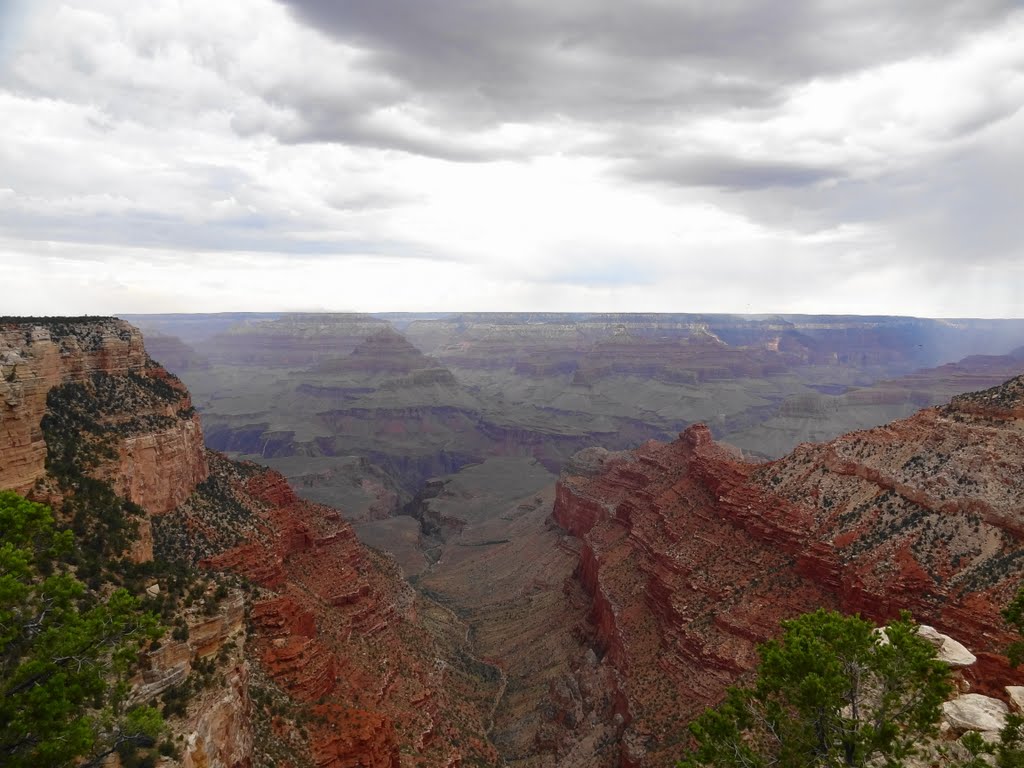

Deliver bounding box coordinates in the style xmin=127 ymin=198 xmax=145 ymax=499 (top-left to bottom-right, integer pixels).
xmin=157 ymin=455 xmax=498 ymax=768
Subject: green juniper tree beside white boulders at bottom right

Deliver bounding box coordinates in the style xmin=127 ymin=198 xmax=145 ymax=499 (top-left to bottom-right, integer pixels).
xmin=678 ymin=610 xmax=952 ymax=768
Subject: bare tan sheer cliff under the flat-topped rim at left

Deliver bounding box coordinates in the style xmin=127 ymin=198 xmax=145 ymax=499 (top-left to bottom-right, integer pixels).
xmin=0 ymin=318 xmax=207 ymax=528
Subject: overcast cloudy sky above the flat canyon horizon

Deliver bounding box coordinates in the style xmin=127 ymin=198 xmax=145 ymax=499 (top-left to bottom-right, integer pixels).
xmin=0 ymin=0 xmax=1024 ymax=316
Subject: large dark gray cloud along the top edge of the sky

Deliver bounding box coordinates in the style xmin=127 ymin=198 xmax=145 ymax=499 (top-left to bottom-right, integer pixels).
xmin=282 ymin=0 xmax=1019 ymax=125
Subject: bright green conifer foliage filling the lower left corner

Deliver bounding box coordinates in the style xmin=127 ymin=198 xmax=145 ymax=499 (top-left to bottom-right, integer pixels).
xmin=0 ymin=492 xmax=163 ymax=768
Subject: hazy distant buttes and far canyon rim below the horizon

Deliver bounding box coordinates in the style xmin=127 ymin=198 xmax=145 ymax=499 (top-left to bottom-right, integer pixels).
xmin=130 ymin=313 xmax=1024 ymax=536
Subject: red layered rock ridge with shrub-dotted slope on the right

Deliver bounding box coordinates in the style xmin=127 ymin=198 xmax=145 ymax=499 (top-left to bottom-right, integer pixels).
xmin=554 ymin=378 xmax=1024 ymax=765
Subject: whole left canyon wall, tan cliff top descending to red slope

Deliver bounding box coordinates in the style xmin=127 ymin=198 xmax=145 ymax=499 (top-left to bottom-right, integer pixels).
xmin=0 ymin=319 xmax=498 ymax=768
